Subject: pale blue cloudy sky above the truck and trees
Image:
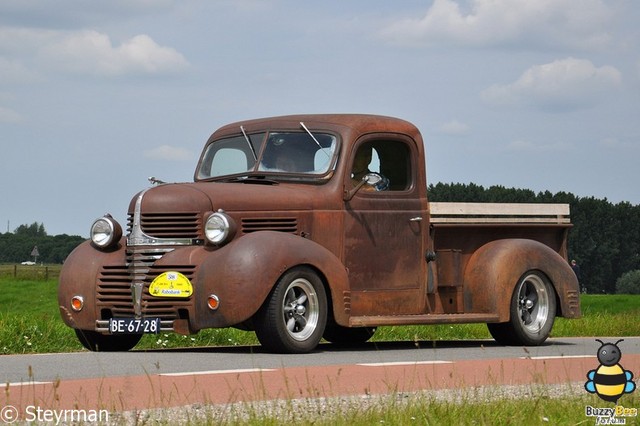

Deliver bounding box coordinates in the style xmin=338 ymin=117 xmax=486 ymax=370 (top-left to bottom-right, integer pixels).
xmin=0 ymin=0 xmax=640 ymax=237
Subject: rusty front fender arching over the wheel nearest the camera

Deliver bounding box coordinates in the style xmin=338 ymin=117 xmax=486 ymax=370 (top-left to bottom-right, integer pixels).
xmin=192 ymin=231 xmax=349 ymax=330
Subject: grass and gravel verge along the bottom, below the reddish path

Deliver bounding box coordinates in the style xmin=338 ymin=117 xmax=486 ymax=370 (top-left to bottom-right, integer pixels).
xmin=122 ymin=383 xmax=640 ymax=426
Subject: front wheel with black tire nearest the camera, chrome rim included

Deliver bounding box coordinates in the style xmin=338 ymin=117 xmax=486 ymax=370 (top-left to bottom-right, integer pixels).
xmin=253 ymin=267 xmax=327 ymax=353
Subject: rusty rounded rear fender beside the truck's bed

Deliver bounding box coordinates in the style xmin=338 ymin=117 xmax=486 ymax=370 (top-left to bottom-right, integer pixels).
xmin=464 ymin=239 xmax=580 ymax=322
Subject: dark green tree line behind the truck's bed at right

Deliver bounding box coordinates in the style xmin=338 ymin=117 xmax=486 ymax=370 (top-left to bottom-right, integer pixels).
xmin=428 ymin=183 xmax=640 ymax=293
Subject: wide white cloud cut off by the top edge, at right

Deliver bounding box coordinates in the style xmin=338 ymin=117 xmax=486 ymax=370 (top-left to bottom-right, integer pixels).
xmin=381 ymin=0 xmax=612 ymax=49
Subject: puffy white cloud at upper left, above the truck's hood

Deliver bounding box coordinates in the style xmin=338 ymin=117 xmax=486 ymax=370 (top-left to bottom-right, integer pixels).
xmin=40 ymin=31 xmax=188 ymax=76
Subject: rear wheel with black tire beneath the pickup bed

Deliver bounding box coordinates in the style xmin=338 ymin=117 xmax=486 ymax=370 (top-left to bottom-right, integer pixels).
xmin=487 ymin=271 xmax=556 ymax=346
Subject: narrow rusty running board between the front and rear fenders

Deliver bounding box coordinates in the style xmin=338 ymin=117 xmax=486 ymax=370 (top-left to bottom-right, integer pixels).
xmin=349 ymin=314 xmax=499 ymax=327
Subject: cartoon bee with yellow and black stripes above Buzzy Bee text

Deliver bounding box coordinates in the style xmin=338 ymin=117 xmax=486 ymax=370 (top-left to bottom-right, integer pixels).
xmin=584 ymin=339 xmax=636 ymax=403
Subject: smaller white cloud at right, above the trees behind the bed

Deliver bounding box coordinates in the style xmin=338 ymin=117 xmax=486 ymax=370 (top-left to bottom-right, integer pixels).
xmin=481 ymin=58 xmax=622 ymax=110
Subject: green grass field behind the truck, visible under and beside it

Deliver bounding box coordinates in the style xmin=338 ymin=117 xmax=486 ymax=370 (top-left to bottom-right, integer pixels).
xmin=0 ymin=276 xmax=640 ymax=354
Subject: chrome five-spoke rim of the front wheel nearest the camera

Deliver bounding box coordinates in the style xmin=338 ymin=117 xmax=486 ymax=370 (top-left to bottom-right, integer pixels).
xmin=282 ymin=278 xmax=320 ymax=341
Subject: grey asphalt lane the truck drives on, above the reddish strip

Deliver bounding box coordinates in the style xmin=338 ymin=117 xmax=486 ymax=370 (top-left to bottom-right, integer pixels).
xmin=5 ymin=337 xmax=640 ymax=384
